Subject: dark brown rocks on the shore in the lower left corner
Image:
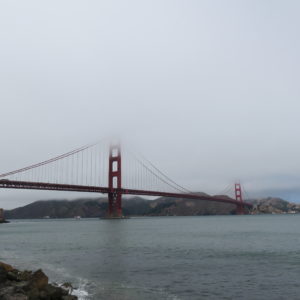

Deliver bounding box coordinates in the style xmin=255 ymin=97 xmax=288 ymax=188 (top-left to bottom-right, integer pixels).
xmin=0 ymin=262 xmax=78 ymax=300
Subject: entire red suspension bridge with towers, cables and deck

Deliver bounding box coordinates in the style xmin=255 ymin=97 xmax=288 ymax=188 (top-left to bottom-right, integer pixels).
xmin=0 ymin=141 xmax=252 ymax=218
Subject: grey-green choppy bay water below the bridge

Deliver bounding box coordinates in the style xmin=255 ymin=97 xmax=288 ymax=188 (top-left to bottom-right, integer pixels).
xmin=0 ymin=215 xmax=300 ymax=300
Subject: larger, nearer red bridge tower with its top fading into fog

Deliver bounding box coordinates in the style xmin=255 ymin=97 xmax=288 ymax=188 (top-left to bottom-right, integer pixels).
xmin=108 ymin=144 xmax=122 ymax=218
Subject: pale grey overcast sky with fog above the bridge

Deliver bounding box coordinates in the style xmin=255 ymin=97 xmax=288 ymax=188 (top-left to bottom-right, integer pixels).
xmin=0 ymin=0 xmax=300 ymax=208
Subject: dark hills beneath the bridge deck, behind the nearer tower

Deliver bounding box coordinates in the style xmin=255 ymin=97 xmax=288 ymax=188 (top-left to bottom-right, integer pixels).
xmin=5 ymin=196 xmax=236 ymax=219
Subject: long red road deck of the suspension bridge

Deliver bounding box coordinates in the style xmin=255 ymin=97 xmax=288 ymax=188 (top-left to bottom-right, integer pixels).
xmin=0 ymin=179 xmax=253 ymax=208
